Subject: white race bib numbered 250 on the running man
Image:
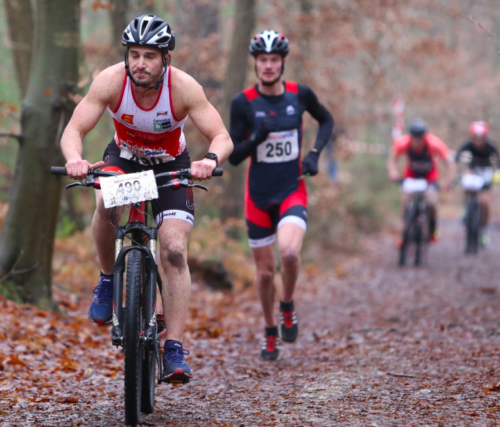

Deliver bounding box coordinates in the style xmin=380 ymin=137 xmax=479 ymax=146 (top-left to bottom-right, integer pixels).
xmin=257 ymin=129 xmax=299 ymax=163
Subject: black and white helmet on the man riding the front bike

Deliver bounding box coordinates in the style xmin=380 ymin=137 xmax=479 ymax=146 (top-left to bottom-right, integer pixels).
xmin=122 ymin=15 xmax=175 ymax=51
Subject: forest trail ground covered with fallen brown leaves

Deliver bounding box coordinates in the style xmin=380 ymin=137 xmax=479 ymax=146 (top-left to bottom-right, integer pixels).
xmin=0 ymin=221 xmax=500 ymax=427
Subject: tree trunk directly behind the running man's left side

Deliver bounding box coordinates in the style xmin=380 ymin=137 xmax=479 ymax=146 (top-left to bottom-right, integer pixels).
xmin=221 ymin=0 xmax=256 ymax=218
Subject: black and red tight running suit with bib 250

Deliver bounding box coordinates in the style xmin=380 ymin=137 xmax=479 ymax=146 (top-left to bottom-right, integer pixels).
xmin=229 ymin=82 xmax=333 ymax=247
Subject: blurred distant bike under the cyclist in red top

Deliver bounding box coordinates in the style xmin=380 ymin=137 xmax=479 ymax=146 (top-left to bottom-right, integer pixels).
xmin=399 ymin=178 xmax=430 ymax=266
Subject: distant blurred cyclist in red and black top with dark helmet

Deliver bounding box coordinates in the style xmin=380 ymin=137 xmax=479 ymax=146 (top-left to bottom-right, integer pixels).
xmin=387 ymin=119 xmax=455 ymax=241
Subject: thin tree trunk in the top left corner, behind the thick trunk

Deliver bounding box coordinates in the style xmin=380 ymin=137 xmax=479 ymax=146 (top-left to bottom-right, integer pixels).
xmin=5 ymin=0 xmax=33 ymax=98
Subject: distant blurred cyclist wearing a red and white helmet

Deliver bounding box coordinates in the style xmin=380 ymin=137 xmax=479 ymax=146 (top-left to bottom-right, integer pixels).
xmin=456 ymin=122 xmax=500 ymax=246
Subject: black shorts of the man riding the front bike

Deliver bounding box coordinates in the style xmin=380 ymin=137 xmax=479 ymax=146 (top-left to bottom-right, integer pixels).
xmin=102 ymin=140 xmax=194 ymax=225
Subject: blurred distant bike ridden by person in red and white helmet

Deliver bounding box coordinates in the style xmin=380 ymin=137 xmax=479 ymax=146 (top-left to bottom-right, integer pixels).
xmin=461 ymin=173 xmax=485 ymax=254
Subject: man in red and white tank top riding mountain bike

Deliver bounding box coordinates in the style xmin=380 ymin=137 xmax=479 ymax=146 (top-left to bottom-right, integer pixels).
xmin=61 ymin=15 xmax=233 ymax=381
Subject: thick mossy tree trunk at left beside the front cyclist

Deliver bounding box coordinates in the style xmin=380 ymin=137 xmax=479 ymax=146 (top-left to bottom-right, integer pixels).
xmin=0 ymin=0 xmax=80 ymax=309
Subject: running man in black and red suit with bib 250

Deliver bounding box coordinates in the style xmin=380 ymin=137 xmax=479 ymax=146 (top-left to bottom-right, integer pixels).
xmin=229 ymin=31 xmax=333 ymax=360
